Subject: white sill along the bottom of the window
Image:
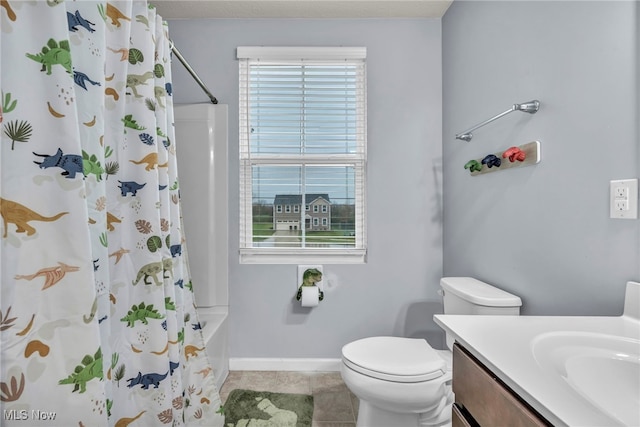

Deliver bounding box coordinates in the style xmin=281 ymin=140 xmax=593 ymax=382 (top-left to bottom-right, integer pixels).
xmin=240 ymin=248 xmax=367 ymax=264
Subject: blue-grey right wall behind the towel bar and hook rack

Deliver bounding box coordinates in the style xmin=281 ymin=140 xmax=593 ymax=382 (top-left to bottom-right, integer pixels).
xmin=442 ymin=0 xmax=640 ymax=315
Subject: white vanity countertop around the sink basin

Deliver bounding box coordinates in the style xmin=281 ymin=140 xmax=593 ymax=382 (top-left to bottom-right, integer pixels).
xmin=434 ymin=315 xmax=640 ymax=427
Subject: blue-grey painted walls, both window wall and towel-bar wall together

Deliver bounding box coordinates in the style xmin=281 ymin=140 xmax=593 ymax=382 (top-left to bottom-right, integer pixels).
xmin=169 ymin=0 xmax=640 ymax=357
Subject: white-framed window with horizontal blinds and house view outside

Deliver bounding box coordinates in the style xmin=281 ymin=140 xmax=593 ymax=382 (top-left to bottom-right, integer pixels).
xmin=237 ymin=47 xmax=366 ymax=263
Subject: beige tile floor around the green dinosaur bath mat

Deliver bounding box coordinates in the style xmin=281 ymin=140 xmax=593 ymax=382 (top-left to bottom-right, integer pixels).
xmin=220 ymin=371 xmax=358 ymax=427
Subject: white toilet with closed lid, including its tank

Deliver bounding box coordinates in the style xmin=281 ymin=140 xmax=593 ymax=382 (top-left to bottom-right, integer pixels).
xmin=340 ymin=277 xmax=522 ymax=427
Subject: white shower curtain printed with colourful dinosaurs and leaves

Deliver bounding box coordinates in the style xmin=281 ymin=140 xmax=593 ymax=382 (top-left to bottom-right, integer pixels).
xmin=0 ymin=0 xmax=223 ymax=427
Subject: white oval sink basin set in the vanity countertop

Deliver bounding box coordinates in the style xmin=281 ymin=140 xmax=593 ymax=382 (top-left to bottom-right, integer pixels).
xmin=532 ymin=331 xmax=640 ymax=426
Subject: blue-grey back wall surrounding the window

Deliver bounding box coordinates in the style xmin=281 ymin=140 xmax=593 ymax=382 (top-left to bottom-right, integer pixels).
xmin=169 ymin=19 xmax=442 ymax=358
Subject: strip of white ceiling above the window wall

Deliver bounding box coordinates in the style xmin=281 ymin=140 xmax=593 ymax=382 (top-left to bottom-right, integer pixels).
xmin=151 ymin=0 xmax=453 ymax=19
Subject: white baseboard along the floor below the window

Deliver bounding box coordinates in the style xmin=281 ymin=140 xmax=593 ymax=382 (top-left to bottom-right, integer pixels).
xmin=229 ymin=357 xmax=342 ymax=372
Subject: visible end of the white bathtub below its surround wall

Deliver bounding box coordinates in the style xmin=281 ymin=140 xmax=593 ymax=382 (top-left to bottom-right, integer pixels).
xmin=197 ymin=306 xmax=229 ymax=390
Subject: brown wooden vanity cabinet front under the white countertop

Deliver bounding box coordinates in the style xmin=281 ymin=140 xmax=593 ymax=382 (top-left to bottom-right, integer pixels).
xmin=452 ymin=343 xmax=552 ymax=427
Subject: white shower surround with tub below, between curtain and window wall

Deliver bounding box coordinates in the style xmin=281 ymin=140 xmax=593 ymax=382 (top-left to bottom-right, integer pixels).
xmin=174 ymin=103 xmax=229 ymax=389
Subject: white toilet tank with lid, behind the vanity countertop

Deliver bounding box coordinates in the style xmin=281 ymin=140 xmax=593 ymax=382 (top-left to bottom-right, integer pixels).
xmin=440 ymin=277 xmax=522 ymax=315
